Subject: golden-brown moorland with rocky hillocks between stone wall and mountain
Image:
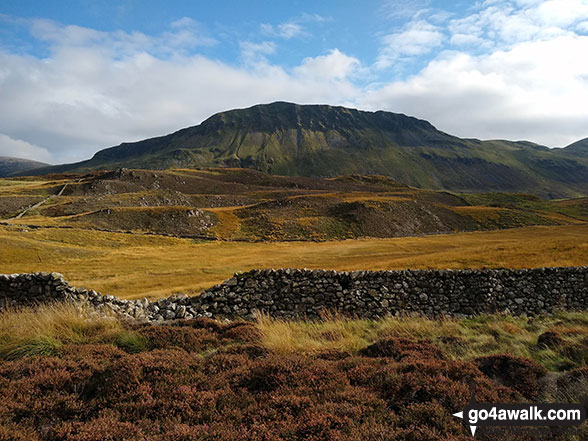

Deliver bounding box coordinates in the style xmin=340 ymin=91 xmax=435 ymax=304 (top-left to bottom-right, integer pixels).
xmin=0 ymin=169 xmax=588 ymax=298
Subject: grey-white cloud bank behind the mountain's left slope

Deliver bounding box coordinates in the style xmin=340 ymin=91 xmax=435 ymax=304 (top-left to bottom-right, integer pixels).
xmin=0 ymin=19 xmax=358 ymax=162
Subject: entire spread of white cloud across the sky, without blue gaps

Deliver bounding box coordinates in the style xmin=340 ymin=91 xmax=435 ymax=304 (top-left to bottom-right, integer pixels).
xmin=0 ymin=0 xmax=588 ymax=166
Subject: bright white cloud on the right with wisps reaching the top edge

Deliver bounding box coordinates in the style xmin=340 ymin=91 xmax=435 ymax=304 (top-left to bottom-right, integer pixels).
xmin=358 ymin=0 xmax=588 ymax=146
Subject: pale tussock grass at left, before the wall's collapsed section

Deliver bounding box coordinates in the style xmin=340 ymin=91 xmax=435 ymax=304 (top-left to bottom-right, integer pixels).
xmin=0 ymin=303 xmax=144 ymax=360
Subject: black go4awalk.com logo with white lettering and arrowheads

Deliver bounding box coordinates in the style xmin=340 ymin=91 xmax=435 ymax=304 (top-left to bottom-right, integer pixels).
xmin=453 ymin=384 xmax=586 ymax=436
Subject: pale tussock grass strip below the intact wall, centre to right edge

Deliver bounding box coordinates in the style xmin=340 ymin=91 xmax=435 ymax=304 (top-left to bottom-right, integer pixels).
xmin=256 ymin=312 xmax=588 ymax=371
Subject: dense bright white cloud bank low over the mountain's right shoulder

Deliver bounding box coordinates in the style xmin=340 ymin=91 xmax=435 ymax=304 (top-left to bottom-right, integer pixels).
xmin=361 ymin=36 xmax=588 ymax=146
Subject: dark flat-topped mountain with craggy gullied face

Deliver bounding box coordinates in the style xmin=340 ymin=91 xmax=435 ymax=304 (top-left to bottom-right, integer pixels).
xmin=24 ymin=102 xmax=588 ymax=198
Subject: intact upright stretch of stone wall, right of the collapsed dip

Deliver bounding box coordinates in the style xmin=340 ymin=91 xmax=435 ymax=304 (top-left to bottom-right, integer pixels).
xmin=192 ymin=267 xmax=588 ymax=319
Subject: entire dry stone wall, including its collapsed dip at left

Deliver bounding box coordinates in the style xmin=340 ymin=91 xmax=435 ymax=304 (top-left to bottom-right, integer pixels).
xmin=0 ymin=267 xmax=588 ymax=321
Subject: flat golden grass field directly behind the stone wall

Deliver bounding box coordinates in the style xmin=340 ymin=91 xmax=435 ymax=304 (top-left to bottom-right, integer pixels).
xmin=0 ymin=224 xmax=588 ymax=298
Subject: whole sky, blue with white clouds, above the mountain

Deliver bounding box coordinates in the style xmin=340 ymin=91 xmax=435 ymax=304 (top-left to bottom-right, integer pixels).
xmin=0 ymin=0 xmax=588 ymax=163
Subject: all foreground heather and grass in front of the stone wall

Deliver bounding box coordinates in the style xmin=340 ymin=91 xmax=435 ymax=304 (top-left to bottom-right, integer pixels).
xmin=0 ymin=306 xmax=588 ymax=441
